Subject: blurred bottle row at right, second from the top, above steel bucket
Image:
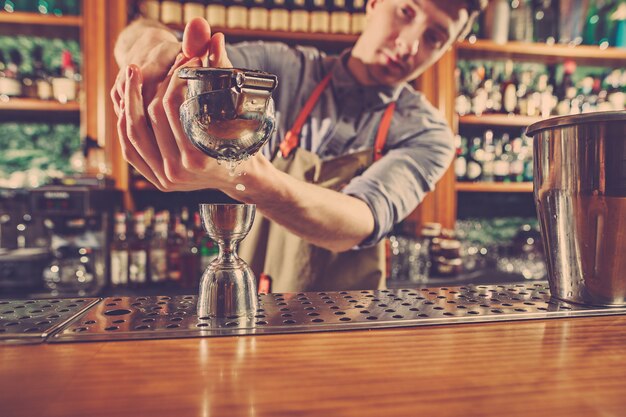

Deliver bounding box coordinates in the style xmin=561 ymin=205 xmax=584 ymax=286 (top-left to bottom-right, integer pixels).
xmin=455 ymin=60 xmax=626 ymax=118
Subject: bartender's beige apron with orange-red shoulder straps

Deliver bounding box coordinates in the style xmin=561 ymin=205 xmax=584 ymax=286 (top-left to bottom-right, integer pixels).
xmin=238 ymin=74 xmax=395 ymax=292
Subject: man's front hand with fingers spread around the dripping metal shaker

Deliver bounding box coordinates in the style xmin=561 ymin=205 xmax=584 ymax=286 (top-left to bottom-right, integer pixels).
xmin=113 ymin=19 xmax=234 ymax=192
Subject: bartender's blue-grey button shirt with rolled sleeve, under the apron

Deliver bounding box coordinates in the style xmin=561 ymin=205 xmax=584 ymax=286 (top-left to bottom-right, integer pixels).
xmin=227 ymin=42 xmax=454 ymax=247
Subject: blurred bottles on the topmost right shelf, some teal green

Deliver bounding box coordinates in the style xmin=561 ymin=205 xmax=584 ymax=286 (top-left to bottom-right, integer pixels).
xmin=470 ymin=0 xmax=626 ymax=48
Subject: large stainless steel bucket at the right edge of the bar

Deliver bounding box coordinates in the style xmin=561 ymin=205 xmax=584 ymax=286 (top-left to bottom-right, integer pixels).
xmin=527 ymin=111 xmax=626 ymax=306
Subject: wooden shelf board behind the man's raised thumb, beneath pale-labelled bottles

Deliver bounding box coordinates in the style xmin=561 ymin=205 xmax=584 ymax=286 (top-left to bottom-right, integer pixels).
xmin=169 ymin=25 xmax=358 ymax=49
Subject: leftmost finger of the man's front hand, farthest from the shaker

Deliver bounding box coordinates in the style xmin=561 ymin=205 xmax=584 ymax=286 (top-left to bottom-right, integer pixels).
xmin=123 ymin=65 xmax=166 ymax=184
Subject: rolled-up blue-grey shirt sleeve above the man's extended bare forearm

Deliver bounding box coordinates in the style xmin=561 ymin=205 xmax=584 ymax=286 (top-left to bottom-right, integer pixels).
xmin=343 ymin=109 xmax=454 ymax=249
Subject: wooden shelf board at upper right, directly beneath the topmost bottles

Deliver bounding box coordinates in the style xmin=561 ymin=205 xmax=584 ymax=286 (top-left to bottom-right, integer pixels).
xmin=457 ymin=39 xmax=626 ymax=67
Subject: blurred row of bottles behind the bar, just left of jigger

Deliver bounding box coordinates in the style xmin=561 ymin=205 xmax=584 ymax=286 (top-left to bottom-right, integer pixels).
xmin=110 ymin=207 xmax=218 ymax=288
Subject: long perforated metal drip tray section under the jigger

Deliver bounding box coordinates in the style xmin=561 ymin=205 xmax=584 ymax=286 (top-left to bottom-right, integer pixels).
xmin=48 ymin=284 xmax=626 ymax=342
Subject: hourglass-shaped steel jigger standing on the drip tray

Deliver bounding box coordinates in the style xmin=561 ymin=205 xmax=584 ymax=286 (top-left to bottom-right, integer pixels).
xmin=198 ymin=204 xmax=258 ymax=318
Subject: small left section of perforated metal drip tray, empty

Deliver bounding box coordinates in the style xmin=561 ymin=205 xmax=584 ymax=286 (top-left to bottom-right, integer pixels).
xmin=0 ymin=298 xmax=98 ymax=344
